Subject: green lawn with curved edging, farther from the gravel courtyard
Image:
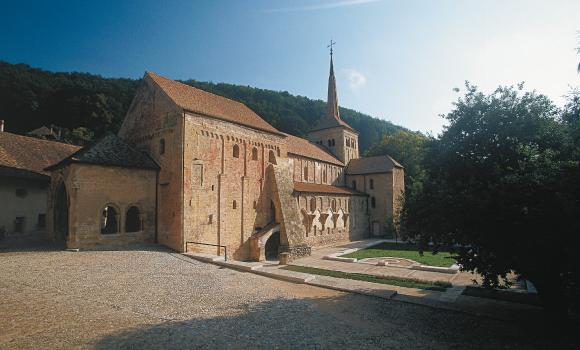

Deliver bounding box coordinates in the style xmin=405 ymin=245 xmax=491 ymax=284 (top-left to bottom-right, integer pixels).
xmin=343 ymin=243 xmax=455 ymax=267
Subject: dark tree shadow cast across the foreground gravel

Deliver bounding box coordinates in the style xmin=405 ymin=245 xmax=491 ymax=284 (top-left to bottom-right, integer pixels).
xmin=94 ymin=294 xmax=578 ymax=349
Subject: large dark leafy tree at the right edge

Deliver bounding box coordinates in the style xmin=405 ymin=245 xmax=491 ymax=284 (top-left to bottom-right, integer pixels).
xmin=403 ymin=84 xmax=580 ymax=314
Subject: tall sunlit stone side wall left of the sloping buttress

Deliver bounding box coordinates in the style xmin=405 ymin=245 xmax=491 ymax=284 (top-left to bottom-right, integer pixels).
xmin=182 ymin=113 xmax=287 ymax=260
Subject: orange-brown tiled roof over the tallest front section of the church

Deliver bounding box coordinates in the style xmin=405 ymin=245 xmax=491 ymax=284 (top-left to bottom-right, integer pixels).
xmin=146 ymin=72 xmax=281 ymax=134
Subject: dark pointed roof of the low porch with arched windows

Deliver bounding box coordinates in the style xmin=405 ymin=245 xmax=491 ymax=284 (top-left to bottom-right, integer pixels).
xmin=47 ymin=133 xmax=159 ymax=170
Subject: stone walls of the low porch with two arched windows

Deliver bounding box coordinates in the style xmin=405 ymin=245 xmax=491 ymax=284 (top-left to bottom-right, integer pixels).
xmin=49 ymin=164 xmax=157 ymax=248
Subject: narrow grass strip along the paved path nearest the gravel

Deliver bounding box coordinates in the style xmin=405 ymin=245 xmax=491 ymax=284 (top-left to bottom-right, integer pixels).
xmin=283 ymin=265 xmax=451 ymax=292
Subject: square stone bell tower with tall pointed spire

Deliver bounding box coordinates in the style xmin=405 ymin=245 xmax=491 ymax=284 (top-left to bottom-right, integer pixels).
xmin=308 ymin=40 xmax=359 ymax=165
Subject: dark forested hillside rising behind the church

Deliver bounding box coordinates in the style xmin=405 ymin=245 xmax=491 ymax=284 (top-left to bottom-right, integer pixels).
xmin=0 ymin=61 xmax=403 ymax=151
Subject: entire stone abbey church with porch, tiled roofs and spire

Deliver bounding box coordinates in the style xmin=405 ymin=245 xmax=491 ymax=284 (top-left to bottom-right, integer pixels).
xmin=40 ymin=57 xmax=404 ymax=260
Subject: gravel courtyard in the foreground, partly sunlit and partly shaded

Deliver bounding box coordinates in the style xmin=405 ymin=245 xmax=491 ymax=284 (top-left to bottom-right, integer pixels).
xmin=0 ymin=247 xmax=570 ymax=349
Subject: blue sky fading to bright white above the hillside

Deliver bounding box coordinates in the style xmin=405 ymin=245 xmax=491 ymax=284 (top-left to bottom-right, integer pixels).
xmin=0 ymin=0 xmax=580 ymax=133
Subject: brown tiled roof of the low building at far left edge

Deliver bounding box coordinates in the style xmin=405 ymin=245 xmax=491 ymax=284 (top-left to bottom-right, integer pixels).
xmin=0 ymin=132 xmax=80 ymax=177
